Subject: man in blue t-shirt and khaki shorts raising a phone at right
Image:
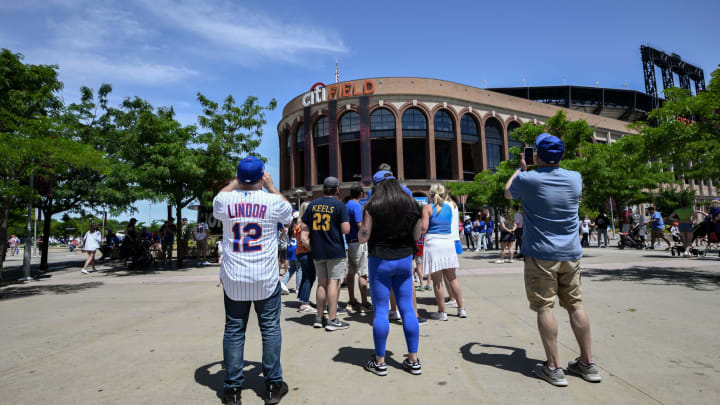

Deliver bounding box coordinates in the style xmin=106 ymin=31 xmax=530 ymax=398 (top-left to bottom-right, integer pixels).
xmin=505 ymin=133 xmax=602 ymax=387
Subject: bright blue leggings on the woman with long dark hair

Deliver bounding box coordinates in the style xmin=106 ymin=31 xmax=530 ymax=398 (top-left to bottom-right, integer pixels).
xmin=368 ymin=256 xmax=420 ymax=357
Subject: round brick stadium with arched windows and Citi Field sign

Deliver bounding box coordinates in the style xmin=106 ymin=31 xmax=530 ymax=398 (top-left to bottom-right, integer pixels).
xmin=277 ymin=77 xmax=714 ymax=197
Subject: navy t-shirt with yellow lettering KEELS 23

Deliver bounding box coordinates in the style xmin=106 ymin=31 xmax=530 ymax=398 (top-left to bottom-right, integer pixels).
xmin=302 ymin=197 xmax=349 ymax=260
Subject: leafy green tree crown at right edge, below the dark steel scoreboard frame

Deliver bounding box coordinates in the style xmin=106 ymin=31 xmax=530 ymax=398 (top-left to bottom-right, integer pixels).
xmin=633 ymin=69 xmax=720 ymax=180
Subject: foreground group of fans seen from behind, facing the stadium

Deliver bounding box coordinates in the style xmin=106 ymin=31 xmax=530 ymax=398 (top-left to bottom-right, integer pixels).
xmin=213 ymin=134 xmax=602 ymax=404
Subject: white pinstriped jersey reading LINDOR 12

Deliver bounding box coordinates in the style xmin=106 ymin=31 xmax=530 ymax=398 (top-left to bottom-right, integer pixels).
xmin=213 ymin=190 xmax=292 ymax=301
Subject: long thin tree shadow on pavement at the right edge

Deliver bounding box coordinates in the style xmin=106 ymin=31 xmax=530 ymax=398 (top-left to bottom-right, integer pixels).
xmin=582 ymin=266 xmax=720 ymax=291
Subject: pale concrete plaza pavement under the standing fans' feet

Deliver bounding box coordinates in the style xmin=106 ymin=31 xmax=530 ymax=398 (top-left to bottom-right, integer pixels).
xmin=0 ymin=248 xmax=720 ymax=405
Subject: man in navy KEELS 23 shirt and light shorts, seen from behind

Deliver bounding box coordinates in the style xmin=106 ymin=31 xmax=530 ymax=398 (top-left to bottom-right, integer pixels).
xmin=300 ymin=176 xmax=350 ymax=331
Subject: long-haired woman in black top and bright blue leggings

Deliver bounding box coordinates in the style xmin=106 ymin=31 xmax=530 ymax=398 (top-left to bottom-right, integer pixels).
xmin=358 ymin=172 xmax=422 ymax=376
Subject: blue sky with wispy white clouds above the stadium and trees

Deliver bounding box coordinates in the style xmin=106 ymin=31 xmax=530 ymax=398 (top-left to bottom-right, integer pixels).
xmin=0 ymin=0 xmax=720 ymax=220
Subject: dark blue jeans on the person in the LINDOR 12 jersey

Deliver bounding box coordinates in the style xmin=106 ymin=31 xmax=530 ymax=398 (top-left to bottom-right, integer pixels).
xmin=223 ymin=283 xmax=282 ymax=390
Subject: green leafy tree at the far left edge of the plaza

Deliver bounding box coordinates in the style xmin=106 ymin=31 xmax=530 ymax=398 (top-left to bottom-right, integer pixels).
xmin=0 ymin=49 xmax=102 ymax=279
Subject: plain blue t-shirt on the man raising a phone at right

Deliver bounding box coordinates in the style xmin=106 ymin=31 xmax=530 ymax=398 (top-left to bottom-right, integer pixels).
xmin=510 ymin=167 xmax=582 ymax=261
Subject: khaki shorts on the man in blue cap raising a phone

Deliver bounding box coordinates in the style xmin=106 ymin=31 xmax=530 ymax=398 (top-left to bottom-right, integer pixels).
xmin=525 ymin=256 xmax=582 ymax=312
